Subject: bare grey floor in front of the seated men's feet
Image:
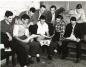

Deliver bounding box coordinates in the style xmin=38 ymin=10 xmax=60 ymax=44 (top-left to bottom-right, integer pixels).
xmin=2 ymin=56 xmax=86 ymax=67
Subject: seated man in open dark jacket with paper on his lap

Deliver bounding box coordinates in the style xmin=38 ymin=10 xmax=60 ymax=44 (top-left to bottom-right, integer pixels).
xmin=61 ymin=17 xmax=80 ymax=60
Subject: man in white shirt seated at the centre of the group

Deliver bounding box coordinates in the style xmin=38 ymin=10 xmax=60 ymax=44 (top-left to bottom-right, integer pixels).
xmin=37 ymin=15 xmax=52 ymax=60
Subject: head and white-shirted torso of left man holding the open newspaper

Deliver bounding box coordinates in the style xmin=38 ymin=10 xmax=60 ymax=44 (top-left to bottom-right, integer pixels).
xmin=13 ymin=14 xmax=30 ymax=46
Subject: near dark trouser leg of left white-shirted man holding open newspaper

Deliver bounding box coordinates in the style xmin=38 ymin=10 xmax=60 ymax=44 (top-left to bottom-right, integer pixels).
xmin=11 ymin=38 xmax=28 ymax=66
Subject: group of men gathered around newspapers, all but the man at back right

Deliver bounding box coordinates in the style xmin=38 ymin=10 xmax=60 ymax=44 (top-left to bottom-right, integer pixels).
xmin=1 ymin=5 xmax=86 ymax=67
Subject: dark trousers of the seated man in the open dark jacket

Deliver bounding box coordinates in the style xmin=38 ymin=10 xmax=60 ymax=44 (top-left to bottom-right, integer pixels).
xmin=61 ymin=40 xmax=81 ymax=59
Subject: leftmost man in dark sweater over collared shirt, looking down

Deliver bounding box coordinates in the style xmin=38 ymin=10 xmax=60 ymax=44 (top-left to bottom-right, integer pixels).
xmin=1 ymin=11 xmax=14 ymax=65
